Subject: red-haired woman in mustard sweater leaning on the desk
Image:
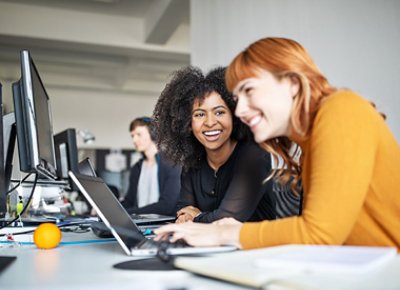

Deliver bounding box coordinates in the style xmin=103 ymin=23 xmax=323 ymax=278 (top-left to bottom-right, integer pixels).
xmin=155 ymin=38 xmax=400 ymax=250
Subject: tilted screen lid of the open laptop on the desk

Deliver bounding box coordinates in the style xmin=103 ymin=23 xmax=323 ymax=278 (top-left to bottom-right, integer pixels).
xmin=69 ymin=172 xmax=144 ymax=251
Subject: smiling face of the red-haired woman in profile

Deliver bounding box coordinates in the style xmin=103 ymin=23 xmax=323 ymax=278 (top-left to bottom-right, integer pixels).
xmin=233 ymin=70 xmax=299 ymax=143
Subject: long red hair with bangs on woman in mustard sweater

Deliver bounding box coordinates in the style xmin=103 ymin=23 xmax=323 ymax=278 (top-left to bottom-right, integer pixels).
xmin=225 ymin=37 xmax=336 ymax=192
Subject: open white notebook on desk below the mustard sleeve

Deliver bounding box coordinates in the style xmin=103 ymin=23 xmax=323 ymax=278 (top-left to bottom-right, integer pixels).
xmin=174 ymin=245 xmax=397 ymax=288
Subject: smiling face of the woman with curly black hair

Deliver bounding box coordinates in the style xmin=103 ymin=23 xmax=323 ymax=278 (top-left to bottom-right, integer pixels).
xmin=192 ymin=92 xmax=233 ymax=151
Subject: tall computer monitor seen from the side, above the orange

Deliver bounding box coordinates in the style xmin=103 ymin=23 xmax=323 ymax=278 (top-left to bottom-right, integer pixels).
xmin=12 ymin=50 xmax=57 ymax=180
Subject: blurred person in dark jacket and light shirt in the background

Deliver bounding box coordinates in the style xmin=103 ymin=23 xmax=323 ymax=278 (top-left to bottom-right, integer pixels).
xmin=121 ymin=117 xmax=181 ymax=215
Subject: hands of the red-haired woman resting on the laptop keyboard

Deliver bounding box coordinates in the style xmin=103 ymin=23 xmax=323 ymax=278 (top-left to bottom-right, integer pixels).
xmin=154 ymin=218 xmax=242 ymax=248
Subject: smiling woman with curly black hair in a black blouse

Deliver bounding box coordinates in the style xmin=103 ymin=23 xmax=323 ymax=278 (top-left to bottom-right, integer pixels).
xmin=154 ymin=67 xmax=276 ymax=223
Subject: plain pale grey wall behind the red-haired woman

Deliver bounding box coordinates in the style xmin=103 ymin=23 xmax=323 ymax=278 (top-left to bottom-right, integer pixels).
xmin=191 ymin=0 xmax=400 ymax=140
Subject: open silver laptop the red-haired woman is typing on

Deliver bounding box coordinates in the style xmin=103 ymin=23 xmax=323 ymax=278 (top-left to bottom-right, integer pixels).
xmin=69 ymin=171 xmax=237 ymax=256
